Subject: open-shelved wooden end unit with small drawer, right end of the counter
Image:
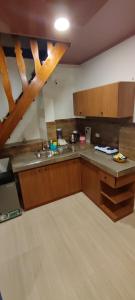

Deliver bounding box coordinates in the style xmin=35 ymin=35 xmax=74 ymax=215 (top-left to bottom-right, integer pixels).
xmin=99 ymin=171 xmax=135 ymax=222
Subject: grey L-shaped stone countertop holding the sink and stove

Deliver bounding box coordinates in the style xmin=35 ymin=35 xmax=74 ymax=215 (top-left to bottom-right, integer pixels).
xmin=12 ymin=144 xmax=135 ymax=177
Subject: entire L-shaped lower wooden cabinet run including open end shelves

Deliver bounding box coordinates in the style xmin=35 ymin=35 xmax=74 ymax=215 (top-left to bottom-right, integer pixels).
xmin=18 ymin=158 xmax=135 ymax=221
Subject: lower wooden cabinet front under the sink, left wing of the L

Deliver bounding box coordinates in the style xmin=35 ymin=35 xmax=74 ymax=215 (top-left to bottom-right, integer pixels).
xmin=18 ymin=159 xmax=81 ymax=210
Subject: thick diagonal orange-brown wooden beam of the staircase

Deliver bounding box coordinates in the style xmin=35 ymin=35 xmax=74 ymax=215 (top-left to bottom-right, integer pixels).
xmin=0 ymin=43 xmax=68 ymax=147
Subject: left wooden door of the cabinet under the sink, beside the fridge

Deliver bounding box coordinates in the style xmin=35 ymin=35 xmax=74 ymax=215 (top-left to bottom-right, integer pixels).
xmin=19 ymin=166 xmax=52 ymax=209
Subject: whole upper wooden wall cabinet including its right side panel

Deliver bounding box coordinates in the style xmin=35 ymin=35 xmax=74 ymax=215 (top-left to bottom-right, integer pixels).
xmin=73 ymin=82 xmax=135 ymax=118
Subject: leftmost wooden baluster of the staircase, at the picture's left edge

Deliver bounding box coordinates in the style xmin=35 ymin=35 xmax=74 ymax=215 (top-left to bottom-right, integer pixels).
xmin=0 ymin=46 xmax=15 ymax=113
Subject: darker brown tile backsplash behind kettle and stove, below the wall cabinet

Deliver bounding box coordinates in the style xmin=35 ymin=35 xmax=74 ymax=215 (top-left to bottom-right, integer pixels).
xmin=47 ymin=118 xmax=131 ymax=147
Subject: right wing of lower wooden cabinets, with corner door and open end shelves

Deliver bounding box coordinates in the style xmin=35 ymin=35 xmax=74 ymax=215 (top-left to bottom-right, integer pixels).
xmin=81 ymin=160 xmax=135 ymax=222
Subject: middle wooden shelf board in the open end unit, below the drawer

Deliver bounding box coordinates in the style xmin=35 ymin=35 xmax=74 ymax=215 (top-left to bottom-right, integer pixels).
xmin=101 ymin=191 xmax=133 ymax=204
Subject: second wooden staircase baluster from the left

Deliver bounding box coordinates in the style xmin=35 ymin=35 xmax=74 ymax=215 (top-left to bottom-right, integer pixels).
xmin=15 ymin=41 xmax=28 ymax=91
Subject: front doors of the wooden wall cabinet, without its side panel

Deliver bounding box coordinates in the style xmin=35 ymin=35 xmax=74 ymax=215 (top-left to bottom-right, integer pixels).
xmin=73 ymin=83 xmax=118 ymax=117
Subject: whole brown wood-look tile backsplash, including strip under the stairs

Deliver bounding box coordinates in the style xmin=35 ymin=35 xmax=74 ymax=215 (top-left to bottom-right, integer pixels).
xmin=0 ymin=118 xmax=132 ymax=159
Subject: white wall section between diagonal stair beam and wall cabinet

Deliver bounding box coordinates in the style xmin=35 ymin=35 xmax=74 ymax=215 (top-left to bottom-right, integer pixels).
xmin=43 ymin=65 xmax=80 ymax=122
